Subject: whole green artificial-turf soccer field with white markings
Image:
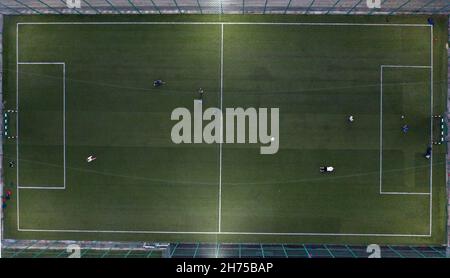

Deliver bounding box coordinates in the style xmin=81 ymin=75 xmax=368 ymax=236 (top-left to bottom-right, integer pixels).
xmin=3 ymin=16 xmax=448 ymax=244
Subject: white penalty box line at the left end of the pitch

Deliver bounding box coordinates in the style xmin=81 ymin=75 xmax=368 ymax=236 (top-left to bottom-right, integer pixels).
xmin=17 ymin=62 xmax=66 ymax=190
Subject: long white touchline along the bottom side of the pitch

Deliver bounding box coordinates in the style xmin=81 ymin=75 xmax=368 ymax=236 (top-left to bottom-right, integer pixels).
xmin=19 ymin=229 xmax=430 ymax=237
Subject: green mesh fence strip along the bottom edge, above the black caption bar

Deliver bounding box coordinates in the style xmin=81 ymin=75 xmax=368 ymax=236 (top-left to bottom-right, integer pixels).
xmin=3 ymin=240 xmax=446 ymax=258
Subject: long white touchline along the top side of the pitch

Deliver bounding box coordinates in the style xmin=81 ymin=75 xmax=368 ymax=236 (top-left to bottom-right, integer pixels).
xmin=17 ymin=21 xmax=430 ymax=27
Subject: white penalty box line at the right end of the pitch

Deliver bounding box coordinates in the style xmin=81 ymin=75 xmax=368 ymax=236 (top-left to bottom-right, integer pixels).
xmin=380 ymin=65 xmax=433 ymax=195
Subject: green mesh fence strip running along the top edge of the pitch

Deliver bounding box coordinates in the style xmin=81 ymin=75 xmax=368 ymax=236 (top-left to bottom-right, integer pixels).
xmin=0 ymin=0 xmax=450 ymax=14
